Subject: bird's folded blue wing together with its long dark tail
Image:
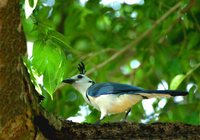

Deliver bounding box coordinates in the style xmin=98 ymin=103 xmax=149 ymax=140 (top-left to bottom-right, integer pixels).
xmin=87 ymin=82 xmax=188 ymax=99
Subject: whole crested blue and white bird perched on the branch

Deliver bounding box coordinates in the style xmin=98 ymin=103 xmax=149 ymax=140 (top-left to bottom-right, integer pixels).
xmin=62 ymin=62 xmax=188 ymax=121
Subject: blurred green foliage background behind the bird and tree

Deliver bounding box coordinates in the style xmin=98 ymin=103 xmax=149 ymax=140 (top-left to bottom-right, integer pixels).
xmin=21 ymin=0 xmax=200 ymax=125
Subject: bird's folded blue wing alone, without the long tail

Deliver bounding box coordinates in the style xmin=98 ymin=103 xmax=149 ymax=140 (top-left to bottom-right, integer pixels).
xmin=87 ymin=82 xmax=144 ymax=97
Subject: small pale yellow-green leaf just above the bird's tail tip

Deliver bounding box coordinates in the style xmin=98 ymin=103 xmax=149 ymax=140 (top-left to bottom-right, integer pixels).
xmin=170 ymin=74 xmax=185 ymax=90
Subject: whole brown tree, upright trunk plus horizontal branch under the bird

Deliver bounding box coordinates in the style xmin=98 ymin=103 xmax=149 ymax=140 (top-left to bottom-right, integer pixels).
xmin=0 ymin=0 xmax=200 ymax=140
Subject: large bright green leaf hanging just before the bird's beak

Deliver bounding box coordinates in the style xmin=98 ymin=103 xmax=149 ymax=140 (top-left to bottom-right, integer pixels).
xmin=32 ymin=40 xmax=67 ymax=98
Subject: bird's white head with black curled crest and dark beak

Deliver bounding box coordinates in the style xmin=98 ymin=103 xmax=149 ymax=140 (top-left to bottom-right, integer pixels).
xmin=63 ymin=63 xmax=95 ymax=94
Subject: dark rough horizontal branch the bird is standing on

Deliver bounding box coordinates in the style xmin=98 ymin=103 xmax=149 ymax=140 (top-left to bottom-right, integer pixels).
xmin=35 ymin=116 xmax=200 ymax=140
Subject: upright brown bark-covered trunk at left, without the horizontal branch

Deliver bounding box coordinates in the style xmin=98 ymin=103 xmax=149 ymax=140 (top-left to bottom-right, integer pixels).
xmin=0 ymin=0 xmax=43 ymax=139
